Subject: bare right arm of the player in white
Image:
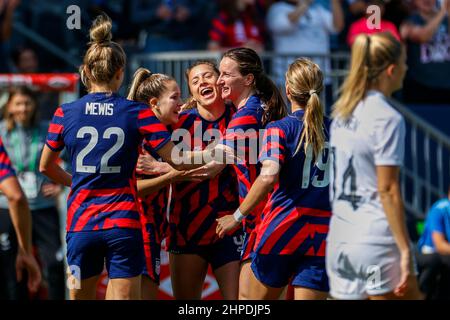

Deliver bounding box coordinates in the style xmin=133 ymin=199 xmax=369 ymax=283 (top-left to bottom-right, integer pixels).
xmin=376 ymin=166 xmax=411 ymax=295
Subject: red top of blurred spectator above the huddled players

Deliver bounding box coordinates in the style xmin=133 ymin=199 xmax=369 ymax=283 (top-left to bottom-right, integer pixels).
xmin=209 ymin=11 xmax=263 ymax=48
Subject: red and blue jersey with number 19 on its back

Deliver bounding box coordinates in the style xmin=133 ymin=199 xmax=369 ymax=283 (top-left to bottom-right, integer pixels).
xmin=254 ymin=110 xmax=331 ymax=257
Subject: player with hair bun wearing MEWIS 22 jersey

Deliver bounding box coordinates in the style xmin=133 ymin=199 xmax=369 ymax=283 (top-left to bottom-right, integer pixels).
xmin=40 ymin=16 xmax=206 ymax=299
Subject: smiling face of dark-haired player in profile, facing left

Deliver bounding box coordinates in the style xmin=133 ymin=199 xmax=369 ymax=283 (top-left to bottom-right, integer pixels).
xmin=217 ymin=57 xmax=251 ymax=106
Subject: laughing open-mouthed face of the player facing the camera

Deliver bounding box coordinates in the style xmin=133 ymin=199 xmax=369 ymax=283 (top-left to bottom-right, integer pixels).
xmin=188 ymin=64 xmax=223 ymax=108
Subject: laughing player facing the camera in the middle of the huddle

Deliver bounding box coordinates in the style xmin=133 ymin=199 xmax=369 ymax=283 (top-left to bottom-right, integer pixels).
xmin=167 ymin=61 xmax=243 ymax=300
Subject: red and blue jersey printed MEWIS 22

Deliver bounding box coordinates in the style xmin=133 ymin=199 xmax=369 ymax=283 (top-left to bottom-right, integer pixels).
xmin=46 ymin=93 xmax=171 ymax=231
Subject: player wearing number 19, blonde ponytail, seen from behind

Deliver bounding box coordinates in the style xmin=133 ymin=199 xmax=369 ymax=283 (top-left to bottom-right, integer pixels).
xmin=217 ymin=59 xmax=331 ymax=299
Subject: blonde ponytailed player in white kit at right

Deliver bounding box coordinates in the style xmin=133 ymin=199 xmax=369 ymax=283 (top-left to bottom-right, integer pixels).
xmin=326 ymin=33 xmax=421 ymax=299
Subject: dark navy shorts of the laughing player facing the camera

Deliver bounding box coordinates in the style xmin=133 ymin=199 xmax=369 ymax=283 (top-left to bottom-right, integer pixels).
xmin=169 ymin=230 xmax=243 ymax=270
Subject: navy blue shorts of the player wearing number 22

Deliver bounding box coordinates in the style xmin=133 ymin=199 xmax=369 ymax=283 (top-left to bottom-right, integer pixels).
xmin=66 ymin=228 xmax=145 ymax=280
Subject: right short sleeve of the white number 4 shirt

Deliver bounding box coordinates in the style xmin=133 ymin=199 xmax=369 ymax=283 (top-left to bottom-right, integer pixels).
xmin=374 ymin=115 xmax=406 ymax=166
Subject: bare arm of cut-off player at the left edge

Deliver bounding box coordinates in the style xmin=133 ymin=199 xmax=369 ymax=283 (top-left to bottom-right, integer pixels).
xmin=0 ymin=176 xmax=41 ymax=292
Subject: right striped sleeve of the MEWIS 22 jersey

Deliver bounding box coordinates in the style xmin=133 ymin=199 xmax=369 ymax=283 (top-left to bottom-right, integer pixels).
xmin=138 ymin=106 xmax=171 ymax=152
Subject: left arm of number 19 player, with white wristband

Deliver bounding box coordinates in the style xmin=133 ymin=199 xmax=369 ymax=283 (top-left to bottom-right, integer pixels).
xmin=216 ymin=160 xmax=280 ymax=238
